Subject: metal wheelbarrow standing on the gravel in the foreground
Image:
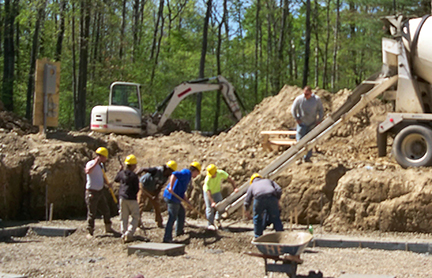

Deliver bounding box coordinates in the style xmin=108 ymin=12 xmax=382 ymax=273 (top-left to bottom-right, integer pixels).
xmin=245 ymin=232 xmax=313 ymax=278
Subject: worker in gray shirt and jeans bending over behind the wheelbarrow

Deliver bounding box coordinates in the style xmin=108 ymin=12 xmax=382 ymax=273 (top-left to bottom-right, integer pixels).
xmin=244 ymin=173 xmax=283 ymax=238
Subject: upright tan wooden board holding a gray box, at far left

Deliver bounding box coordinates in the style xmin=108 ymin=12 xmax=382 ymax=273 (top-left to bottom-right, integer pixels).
xmin=33 ymin=58 xmax=60 ymax=127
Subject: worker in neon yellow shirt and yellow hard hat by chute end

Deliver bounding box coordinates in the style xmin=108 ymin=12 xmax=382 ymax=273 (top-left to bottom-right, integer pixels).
xmin=203 ymin=164 xmax=237 ymax=228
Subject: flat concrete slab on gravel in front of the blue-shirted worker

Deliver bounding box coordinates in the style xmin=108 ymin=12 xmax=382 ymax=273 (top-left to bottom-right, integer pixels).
xmin=128 ymin=242 xmax=185 ymax=256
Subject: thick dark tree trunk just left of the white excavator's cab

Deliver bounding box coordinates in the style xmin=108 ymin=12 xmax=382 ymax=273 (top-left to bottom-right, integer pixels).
xmin=75 ymin=0 xmax=91 ymax=129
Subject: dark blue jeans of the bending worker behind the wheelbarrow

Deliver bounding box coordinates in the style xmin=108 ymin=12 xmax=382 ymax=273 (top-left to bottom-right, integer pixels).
xmin=253 ymin=195 xmax=283 ymax=238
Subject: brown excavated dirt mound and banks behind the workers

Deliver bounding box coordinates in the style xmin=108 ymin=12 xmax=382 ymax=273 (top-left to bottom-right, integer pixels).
xmin=0 ymin=83 xmax=432 ymax=231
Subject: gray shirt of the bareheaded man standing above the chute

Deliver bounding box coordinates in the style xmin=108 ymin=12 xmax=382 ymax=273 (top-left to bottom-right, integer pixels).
xmin=291 ymin=94 xmax=324 ymax=126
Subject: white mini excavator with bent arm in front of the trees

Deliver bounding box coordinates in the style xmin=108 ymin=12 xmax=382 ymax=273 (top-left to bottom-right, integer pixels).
xmin=90 ymin=76 xmax=242 ymax=135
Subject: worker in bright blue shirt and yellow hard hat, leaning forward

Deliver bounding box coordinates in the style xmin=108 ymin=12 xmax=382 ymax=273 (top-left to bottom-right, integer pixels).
xmin=163 ymin=161 xmax=201 ymax=243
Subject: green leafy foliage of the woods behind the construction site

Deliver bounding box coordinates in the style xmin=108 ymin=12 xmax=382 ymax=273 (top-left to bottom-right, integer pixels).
xmin=0 ymin=0 xmax=431 ymax=131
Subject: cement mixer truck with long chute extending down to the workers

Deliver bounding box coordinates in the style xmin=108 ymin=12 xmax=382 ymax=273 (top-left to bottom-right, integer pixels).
xmin=216 ymin=15 xmax=432 ymax=217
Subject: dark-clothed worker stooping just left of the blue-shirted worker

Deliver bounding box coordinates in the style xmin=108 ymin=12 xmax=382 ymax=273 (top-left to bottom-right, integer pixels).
xmin=137 ymin=160 xmax=177 ymax=228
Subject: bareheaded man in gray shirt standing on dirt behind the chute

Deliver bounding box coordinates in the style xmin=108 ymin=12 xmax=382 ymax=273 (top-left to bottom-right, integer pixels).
xmin=291 ymin=86 xmax=324 ymax=162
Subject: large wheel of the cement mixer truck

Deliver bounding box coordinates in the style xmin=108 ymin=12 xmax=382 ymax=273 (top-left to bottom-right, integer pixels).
xmin=393 ymin=125 xmax=432 ymax=168
